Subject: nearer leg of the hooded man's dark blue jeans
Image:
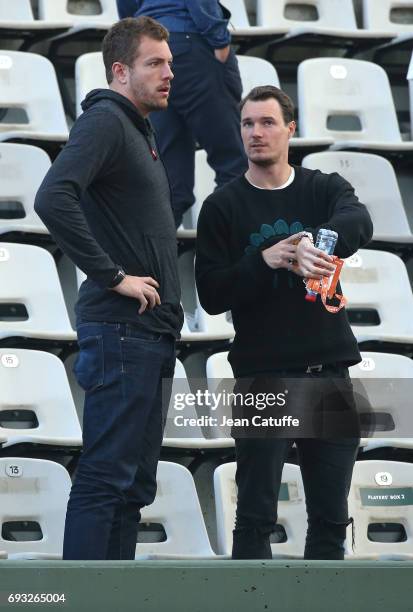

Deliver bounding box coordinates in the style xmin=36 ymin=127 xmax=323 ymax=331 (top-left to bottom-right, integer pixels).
xmin=63 ymin=323 xmax=174 ymax=560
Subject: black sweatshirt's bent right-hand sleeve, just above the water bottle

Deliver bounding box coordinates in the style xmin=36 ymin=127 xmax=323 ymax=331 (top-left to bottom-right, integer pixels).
xmin=314 ymin=172 xmax=373 ymax=258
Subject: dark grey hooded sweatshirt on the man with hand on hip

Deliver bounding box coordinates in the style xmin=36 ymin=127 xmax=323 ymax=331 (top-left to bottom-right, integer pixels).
xmin=35 ymin=89 xmax=183 ymax=338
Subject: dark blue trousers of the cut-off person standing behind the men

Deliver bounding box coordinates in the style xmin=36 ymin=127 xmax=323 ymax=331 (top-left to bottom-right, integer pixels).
xmin=151 ymin=32 xmax=247 ymax=227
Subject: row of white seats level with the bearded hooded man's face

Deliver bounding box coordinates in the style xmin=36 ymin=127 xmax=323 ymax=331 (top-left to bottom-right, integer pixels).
xmin=0 ymin=51 xmax=413 ymax=159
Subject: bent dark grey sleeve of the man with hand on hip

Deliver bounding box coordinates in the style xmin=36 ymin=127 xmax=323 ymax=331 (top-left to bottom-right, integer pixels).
xmin=34 ymin=109 xmax=123 ymax=288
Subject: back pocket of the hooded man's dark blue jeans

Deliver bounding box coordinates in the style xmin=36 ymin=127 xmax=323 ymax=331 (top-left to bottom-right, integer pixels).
xmin=73 ymin=336 xmax=104 ymax=391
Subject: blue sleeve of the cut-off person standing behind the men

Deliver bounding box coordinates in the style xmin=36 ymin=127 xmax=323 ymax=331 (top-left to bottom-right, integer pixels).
xmin=185 ymin=0 xmax=231 ymax=49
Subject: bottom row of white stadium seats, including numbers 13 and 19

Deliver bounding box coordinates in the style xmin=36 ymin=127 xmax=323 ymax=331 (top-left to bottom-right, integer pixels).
xmin=0 ymin=457 xmax=413 ymax=560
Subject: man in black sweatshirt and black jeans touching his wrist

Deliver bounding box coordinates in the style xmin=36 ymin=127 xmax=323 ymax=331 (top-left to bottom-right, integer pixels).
xmin=196 ymin=86 xmax=372 ymax=559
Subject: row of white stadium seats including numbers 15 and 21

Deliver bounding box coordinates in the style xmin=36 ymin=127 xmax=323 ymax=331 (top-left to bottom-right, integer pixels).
xmin=0 ymin=348 xmax=413 ymax=456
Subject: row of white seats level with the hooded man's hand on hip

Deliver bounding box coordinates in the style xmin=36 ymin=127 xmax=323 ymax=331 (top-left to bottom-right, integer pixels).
xmin=0 ymin=239 xmax=413 ymax=352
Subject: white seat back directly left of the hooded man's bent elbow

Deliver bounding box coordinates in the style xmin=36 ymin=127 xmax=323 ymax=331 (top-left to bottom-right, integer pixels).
xmin=0 ymin=143 xmax=50 ymax=234
